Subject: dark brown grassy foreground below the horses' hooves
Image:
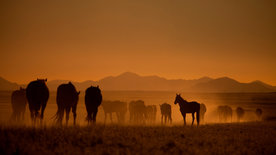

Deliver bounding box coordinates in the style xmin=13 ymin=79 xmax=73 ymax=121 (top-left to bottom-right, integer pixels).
xmin=0 ymin=122 xmax=276 ymax=154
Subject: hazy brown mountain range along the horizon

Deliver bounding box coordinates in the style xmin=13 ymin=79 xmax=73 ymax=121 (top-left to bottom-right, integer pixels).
xmin=0 ymin=72 xmax=276 ymax=92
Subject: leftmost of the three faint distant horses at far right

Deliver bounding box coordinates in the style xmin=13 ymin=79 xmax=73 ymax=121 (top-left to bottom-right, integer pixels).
xmin=217 ymin=105 xmax=233 ymax=122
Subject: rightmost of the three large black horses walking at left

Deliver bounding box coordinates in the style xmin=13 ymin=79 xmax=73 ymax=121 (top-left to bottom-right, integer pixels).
xmin=85 ymin=86 xmax=102 ymax=124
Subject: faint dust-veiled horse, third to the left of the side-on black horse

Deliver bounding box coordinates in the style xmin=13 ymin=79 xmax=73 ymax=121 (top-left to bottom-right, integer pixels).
xmin=129 ymin=100 xmax=147 ymax=124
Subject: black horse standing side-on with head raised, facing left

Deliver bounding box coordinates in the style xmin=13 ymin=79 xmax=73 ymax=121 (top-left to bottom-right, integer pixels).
xmin=174 ymin=94 xmax=200 ymax=125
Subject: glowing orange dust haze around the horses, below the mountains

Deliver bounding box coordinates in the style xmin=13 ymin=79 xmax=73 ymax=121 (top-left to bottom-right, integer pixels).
xmin=0 ymin=91 xmax=276 ymax=125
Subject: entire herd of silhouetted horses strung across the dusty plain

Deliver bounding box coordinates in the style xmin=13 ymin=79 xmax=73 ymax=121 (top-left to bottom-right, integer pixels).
xmin=8 ymin=79 xmax=262 ymax=125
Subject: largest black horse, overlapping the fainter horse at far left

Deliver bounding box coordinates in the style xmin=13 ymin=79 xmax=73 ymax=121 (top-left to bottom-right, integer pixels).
xmin=26 ymin=79 xmax=49 ymax=124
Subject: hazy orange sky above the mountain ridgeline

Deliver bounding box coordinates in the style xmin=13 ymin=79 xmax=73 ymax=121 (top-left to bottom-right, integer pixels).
xmin=0 ymin=0 xmax=276 ymax=85
